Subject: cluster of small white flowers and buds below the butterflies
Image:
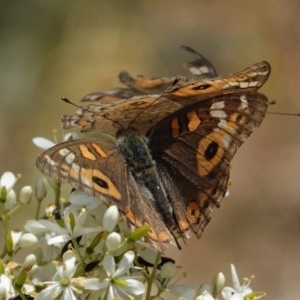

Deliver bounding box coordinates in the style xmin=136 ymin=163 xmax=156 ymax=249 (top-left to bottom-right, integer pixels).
xmin=0 ymin=138 xmax=264 ymax=300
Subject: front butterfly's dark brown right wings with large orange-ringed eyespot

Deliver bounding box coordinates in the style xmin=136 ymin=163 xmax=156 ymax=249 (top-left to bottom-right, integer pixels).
xmin=147 ymin=92 xmax=268 ymax=237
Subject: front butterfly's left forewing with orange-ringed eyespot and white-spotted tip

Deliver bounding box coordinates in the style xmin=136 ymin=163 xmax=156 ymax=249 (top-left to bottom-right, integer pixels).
xmin=36 ymin=139 xmax=128 ymax=211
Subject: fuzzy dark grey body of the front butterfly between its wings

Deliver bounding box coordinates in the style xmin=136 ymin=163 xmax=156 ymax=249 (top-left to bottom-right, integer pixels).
xmin=117 ymin=128 xmax=176 ymax=228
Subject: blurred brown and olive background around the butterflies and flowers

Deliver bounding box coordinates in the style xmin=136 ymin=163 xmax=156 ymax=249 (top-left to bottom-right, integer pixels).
xmin=0 ymin=0 xmax=300 ymax=300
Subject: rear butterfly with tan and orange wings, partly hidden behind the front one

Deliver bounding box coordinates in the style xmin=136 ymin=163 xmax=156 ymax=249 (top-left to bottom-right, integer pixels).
xmin=61 ymin=59 xmax=271 ymax=135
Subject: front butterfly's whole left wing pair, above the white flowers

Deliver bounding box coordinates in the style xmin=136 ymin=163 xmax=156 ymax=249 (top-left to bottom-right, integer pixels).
xmin=36 ymin=139 xmax=175 ymax=251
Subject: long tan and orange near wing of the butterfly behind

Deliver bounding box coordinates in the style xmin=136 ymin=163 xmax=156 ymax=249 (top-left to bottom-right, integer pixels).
xmin=62 ymin=62 xmax=270 ymax=135
